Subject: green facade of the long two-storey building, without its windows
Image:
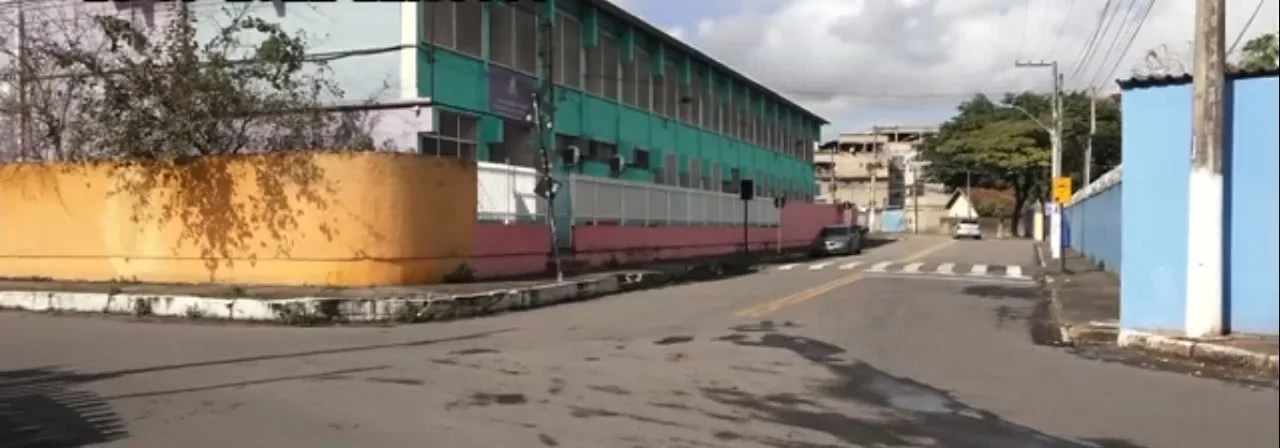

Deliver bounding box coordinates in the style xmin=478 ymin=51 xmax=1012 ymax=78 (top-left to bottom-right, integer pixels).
xmin=417 ymin=0 xmax=826 ymax=197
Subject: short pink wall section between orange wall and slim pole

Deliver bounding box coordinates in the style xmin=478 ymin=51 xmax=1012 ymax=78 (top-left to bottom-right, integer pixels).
xmin=471 ymin=223 xmax=552 ymax=278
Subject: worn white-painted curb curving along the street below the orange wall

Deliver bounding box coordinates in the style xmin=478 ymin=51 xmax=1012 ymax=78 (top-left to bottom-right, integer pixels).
xmin=0 ymin=266 xmax=716 ymax=325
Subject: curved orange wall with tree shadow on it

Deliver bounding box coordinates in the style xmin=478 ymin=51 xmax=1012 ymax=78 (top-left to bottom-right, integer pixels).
xmin=0 ymin=152 xmax=476 ymax=285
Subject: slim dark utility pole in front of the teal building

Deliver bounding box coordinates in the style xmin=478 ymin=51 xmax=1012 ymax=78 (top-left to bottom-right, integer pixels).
xmin=532 ymin=8 xmax=564 ymax=282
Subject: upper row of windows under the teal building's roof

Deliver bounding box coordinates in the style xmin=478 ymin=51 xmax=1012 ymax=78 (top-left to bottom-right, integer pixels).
xmin=422 ymin=1 xmax=813 ymax=165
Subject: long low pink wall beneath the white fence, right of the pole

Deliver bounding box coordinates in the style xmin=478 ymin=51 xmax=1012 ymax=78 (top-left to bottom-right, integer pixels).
xmin=573 ymin=204 xmax=844 ymax=264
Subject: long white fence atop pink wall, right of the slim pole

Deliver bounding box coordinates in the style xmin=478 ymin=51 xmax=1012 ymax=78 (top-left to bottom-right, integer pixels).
xmin=570 ymin=175 xmax=781 ymax=225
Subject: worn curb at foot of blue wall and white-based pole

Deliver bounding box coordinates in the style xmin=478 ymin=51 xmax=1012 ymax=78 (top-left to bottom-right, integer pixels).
xmin=1116 ymin=330 xmax=1280 ymax=376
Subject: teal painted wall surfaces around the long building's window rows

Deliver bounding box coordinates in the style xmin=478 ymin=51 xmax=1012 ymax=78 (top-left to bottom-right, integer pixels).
xmin=419 ymin=0 xmax=819 ymax=196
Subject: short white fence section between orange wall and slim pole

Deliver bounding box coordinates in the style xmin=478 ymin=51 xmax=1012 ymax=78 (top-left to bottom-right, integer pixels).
xmin=476 ymin=161 xmax=547 ymax=224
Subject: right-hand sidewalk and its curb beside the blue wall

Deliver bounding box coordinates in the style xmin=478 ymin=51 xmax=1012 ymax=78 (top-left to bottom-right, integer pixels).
xmin=1036 ymin=243 xmax=1280 ymax=376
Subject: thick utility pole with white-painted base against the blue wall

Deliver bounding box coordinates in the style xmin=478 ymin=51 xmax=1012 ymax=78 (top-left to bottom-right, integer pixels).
xmin=1185 ymin=0 xmax=1226 ymax=338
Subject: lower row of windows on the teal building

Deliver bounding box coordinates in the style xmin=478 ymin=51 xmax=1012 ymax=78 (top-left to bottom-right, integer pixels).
xmin=420 ymin=110 xmax=805 ymax=197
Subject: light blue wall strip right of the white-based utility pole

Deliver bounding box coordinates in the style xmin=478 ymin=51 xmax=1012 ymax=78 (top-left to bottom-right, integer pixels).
xmin=1224 ymin=77 xmax=1280 ymax=334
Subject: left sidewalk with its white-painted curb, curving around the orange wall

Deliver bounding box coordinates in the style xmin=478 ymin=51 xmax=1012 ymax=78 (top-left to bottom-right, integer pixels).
xmin=0 ymin=251 xmax=814 ymax=325
